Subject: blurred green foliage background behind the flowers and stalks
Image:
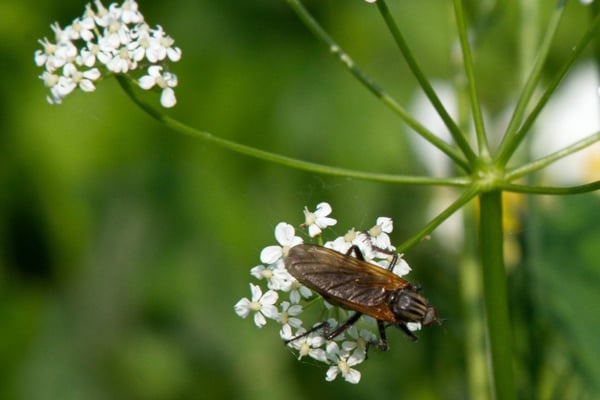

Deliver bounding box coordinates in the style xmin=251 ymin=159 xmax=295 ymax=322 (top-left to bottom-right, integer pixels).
xmin=0 ymin=0 xmax=600 ymax=400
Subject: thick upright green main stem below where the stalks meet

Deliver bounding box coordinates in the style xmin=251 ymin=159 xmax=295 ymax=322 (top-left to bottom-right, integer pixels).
xmin=479 ymin=191 xmax=516 ymax=400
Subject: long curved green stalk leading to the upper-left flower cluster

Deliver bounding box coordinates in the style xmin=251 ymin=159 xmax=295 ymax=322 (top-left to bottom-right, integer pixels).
xmin=116 ymin=75 xmax=470 ymax=187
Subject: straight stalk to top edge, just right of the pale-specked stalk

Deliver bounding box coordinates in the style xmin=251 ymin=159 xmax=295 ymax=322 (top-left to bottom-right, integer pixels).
xmin=376 ymin=0 xmax=477 ymax=165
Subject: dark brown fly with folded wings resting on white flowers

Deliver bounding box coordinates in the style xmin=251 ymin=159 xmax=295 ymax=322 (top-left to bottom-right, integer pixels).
xmin=284 ymin=244 xmax=441 ymax=350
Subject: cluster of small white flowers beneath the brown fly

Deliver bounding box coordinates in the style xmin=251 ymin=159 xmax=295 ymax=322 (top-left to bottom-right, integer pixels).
xmin=234 ymin=203 xmax=420 ymax=383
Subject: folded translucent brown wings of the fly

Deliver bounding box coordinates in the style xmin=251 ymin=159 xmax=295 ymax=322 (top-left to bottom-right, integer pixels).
xmin=285 ymin=244 xmax=409 ymax=321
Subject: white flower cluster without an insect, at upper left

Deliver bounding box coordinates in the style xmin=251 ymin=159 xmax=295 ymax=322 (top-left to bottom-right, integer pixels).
xmin=34 ymin=0 xmax=181 ymax=107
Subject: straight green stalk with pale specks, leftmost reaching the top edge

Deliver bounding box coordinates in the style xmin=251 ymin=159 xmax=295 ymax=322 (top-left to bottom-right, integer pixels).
xmin=287 ymin=0 xmax=470 ymax=172
